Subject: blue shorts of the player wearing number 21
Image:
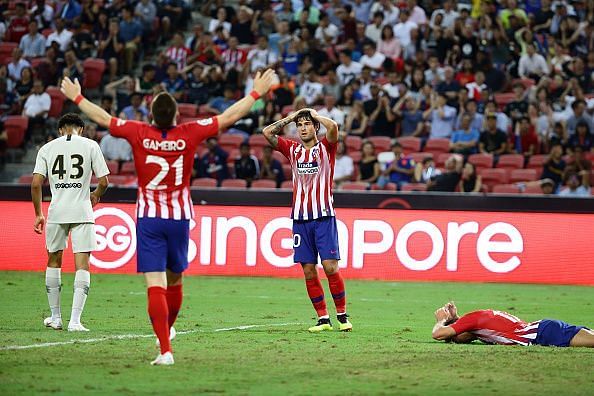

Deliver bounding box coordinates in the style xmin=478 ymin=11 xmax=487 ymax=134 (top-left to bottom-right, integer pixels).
xmin=136 ymin=217 xmax=190 ymax=273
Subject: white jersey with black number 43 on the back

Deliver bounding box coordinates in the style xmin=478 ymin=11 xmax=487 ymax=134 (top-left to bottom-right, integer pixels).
xmin=33 ymin=135 xmax=109 ymax=224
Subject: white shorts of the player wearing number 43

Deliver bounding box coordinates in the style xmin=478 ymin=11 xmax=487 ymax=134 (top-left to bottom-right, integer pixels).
xmin=45 ymin=223 xmax=97 ymax=253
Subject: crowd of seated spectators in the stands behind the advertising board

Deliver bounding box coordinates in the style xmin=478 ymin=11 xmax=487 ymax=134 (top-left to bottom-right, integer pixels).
xmin=0 ymin=0 xmax=594 ymax=196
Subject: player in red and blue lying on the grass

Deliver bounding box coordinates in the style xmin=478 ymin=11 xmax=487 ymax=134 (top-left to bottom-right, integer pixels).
xmin=432 ymin=302 xmax=594 ymax=348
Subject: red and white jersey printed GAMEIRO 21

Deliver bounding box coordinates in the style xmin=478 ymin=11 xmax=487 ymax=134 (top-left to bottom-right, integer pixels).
xmin=109 ymin=117 xmax=219 ymax=220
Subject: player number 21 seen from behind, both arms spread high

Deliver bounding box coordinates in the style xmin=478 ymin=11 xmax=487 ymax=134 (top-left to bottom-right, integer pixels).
xmin=61 ymin=70 xmax=275 ymax=365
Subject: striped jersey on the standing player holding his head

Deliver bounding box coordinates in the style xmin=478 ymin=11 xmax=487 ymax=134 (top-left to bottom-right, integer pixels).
xmin=276 ymin=137 xmax=337 ymax=220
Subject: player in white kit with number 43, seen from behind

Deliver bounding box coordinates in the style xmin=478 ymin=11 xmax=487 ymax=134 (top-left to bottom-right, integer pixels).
xmin=31 ymin=113 xmax=109 ymax=331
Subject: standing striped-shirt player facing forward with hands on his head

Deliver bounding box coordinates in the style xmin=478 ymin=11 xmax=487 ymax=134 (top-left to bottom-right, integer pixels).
xmin=263 ymin=108 xmax=353 ymax=333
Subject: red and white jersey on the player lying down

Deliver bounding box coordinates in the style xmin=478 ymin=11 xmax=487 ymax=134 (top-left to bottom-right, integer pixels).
xmin=450 ymin=309 xmax=540 ymax=345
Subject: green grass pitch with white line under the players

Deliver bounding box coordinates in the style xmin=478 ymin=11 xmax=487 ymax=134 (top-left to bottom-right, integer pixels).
xmin=0 ymin=272 xmax=594 ymax=395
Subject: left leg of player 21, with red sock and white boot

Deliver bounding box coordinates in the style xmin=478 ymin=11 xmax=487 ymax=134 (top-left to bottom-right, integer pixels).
xmin=144 ymin=272 xmax=173 ymax=365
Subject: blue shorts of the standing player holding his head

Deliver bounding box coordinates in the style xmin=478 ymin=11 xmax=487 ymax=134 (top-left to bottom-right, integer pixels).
xmin=293 ymin=216 xmax=340 ymax=265
